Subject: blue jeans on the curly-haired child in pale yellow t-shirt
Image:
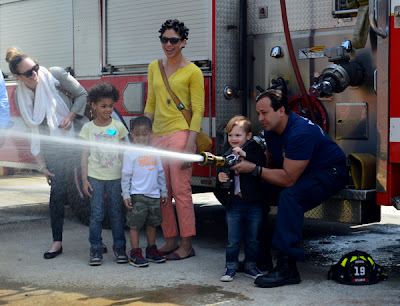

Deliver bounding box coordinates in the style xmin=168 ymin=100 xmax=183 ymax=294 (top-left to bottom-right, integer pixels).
xmin=88 ymin=177 xmax=126 ymax=249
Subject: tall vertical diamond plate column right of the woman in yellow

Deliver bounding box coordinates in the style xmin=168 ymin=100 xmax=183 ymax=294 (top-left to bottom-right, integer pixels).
xmin=215 ymin=0 xmax=241 ymax=154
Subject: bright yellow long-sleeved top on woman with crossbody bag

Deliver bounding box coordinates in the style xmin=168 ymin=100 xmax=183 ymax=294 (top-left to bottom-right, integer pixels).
xmin=144 ymin=61 xmax=204 ymax=136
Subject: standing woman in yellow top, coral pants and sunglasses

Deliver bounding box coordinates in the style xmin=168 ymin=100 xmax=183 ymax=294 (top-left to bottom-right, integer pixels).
xmin=144 ymin=19 xmax=204 ymax=260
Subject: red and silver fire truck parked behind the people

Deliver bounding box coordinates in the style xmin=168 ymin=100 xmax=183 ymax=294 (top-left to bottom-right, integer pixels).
xmin=0 ymin=0 xmax=400 ymax=224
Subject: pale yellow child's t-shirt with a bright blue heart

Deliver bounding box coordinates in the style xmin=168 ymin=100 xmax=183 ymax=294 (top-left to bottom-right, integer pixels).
xmin=79 ymin=119 xmax=128 ymax=181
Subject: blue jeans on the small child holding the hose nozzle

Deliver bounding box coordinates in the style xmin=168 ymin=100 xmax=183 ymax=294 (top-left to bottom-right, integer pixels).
xmin=226 ymin=197 xmax=263 ymax=270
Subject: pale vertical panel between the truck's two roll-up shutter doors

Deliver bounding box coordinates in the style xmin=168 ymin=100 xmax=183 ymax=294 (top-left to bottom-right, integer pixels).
xmin=73 ymin=0 xmax=102 ymax=78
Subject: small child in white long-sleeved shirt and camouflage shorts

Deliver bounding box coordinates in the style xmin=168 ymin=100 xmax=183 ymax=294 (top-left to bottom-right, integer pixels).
xmin=121 ymin=117 xmax=168 ymax=267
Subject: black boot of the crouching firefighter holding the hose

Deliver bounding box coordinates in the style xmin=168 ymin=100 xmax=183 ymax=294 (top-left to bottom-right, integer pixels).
xmin=254 ymin=255 xmax=300 ymax=288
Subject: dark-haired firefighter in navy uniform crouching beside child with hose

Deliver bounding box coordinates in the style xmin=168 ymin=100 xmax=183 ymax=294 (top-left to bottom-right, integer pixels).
xmin=231 ymin=90 xmax=348 ymax=288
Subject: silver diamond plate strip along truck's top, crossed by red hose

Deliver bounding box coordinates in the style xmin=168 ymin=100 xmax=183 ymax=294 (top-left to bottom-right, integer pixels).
xmin=247 ymin=0 xmax=356 ymax=34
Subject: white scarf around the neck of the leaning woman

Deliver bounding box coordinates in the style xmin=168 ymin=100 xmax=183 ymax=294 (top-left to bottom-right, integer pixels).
xmin=17 ymin=66 xmax=75 ymax=156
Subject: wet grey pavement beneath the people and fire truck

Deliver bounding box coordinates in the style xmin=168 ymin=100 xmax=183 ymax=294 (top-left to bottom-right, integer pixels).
xmin=0 ymin=174 xmax=400 ymax=305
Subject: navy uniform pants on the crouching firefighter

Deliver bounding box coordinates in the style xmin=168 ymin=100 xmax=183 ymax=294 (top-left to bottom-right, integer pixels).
xmin=272 ymin=165 xmax=348 ymax=261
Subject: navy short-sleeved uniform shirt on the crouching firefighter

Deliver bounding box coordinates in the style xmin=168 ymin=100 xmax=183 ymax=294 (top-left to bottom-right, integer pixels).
xmin=265 ymin=111 xmax=346 ymax=170
